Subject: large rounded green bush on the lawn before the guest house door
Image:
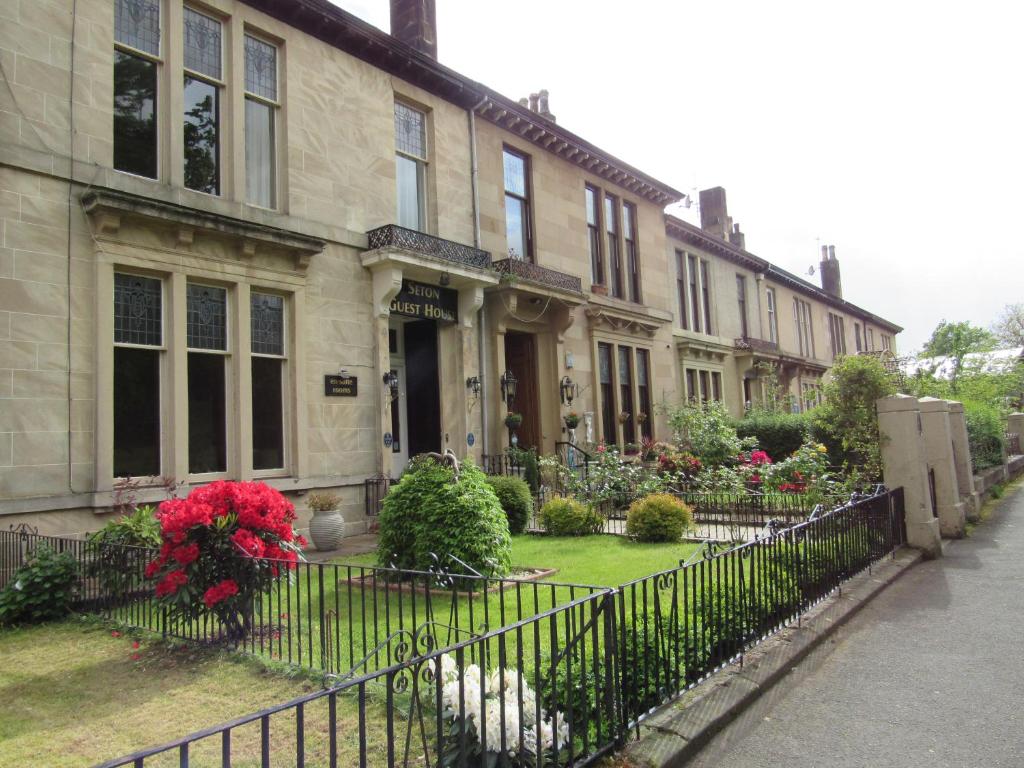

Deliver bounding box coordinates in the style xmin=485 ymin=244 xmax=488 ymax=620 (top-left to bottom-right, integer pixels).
xmin=377 ymin=458 xmax=512 ymax=575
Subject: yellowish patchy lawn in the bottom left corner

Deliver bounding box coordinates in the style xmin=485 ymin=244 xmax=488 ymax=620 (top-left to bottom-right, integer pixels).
xmin=0 ymin=620 xmax=385 ymax=768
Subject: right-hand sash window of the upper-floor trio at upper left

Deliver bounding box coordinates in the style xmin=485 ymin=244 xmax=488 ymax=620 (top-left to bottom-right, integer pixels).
xmin=245 ymin=35 xmax=280 ymax=208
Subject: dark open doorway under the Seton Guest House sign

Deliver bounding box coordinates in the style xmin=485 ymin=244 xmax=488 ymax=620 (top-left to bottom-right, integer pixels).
xmin=388 ymin=316 xmax=441 ymax=476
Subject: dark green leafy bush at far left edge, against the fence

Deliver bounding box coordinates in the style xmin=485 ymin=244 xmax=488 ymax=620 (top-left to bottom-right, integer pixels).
xmin=0 ymin=544 xmax=78 ymax=626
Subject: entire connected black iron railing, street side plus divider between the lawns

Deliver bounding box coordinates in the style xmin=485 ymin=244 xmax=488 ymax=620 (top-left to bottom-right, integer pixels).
xmin=9 ymin=488 xmax=905 ymax=768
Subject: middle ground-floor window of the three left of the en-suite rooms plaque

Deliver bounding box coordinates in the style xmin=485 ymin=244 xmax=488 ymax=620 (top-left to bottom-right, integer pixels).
xmin=185 ymin=283 xmax=228 ymax=474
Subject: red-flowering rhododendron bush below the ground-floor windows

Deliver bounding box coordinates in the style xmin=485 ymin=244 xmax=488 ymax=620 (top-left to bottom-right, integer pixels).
xmin=145 ymin=480 xmax=305 ymax=640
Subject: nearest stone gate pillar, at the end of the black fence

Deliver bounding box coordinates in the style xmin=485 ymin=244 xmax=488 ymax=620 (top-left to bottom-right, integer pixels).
xmin=876 ymin=394 xmax=942 ymax=557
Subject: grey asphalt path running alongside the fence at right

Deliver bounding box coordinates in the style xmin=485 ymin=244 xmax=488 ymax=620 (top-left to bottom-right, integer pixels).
xmin=688 ymin=483 xmax=1024 ymax=768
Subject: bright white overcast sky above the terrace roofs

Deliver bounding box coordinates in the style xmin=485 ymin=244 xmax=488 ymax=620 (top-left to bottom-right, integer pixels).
xmin=335 ymin=0 xmax=1024 ymax=353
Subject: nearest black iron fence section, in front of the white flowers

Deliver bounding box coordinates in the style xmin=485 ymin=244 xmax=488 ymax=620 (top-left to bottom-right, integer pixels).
xmin=101 ymin=590 xmax=622 ymax=768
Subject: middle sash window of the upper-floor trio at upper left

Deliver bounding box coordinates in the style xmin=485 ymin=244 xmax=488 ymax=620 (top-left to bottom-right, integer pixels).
xmin=182 ymin=5 xmax=223 ymax=195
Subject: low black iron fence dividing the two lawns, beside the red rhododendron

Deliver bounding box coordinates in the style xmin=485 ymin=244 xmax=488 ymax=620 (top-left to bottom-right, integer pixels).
xmin=0 ymin=531 xmax=602 ymax=675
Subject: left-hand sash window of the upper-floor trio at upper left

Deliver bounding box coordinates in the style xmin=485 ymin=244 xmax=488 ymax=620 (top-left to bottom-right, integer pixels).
xmin=113 ymin=0 xmax=163 ymax=178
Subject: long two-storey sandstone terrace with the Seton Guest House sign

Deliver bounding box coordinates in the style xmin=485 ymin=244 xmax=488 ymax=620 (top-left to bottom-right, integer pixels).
xmin=0 ymin=0 xmax=899 ymax=532
